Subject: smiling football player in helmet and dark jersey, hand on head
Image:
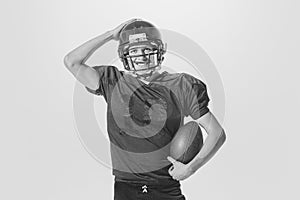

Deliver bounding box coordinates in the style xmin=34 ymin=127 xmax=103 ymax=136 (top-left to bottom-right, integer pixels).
xmin=64 ymin=19 xmax=226 ymax=200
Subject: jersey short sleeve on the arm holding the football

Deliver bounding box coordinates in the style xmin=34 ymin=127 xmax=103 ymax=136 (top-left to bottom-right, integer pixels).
xmin=182 ymin=73 xmax=210 ymax=120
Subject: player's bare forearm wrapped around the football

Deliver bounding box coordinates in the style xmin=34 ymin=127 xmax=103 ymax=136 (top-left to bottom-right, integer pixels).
xmin=189 ymin=129 xmax=226 ymax=172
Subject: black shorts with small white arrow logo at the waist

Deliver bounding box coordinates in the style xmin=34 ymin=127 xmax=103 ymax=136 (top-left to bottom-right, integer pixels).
xmin=114 ymin=180 xmax=185 ymax=200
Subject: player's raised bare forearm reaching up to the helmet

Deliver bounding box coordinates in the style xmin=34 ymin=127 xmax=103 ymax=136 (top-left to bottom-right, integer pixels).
xmin=65 ymin=31 xmax=113 ymax=64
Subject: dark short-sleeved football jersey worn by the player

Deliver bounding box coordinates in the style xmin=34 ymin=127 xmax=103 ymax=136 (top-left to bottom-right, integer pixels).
xmin=86 ymin=66 xmax=209 ymax=182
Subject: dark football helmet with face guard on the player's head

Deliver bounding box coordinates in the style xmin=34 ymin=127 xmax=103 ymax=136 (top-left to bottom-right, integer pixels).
xmin=118 ymin=20 xmax=166 ymax=78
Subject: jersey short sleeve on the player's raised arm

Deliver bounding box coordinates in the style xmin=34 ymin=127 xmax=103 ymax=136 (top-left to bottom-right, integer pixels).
xmin=85 ymin=66 xmax=120 ymax=98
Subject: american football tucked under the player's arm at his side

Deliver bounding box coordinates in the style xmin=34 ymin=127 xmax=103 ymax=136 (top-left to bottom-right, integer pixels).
xmin=170 ymin=121 xmax=203 ymax=164
